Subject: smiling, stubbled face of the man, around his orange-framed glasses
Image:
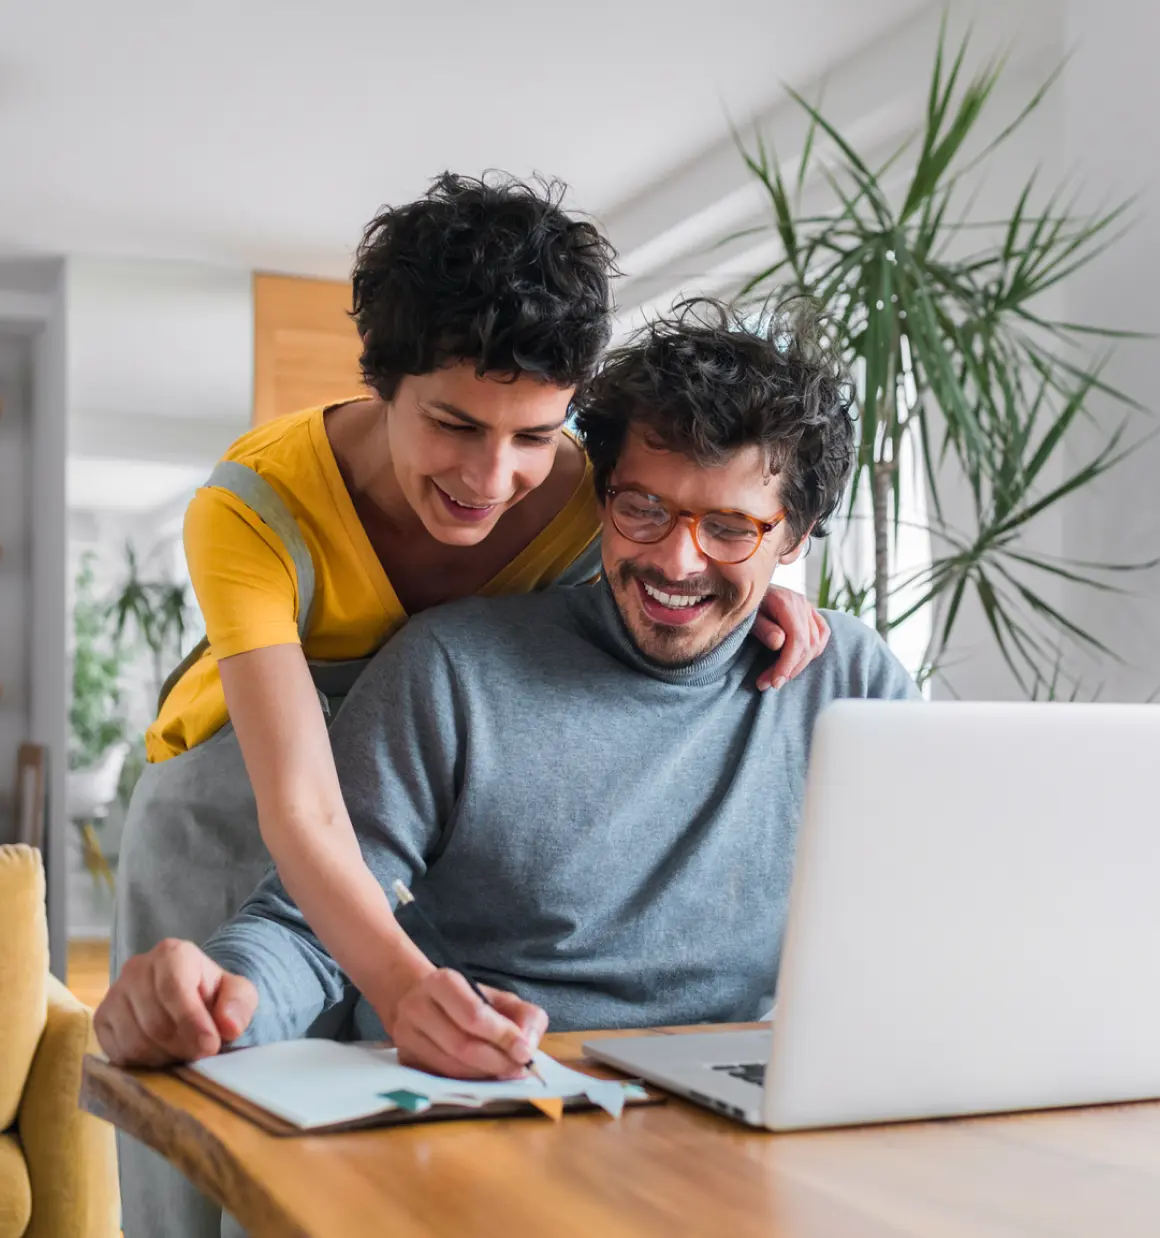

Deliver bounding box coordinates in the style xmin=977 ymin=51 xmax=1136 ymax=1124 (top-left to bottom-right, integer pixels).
xmin=603 ymin=427 xmax=803 ymax=666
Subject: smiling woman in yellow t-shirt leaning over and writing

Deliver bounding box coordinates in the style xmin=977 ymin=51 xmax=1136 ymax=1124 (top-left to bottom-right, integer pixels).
xmin=113 ymin=175 xmax=827 ymax=1065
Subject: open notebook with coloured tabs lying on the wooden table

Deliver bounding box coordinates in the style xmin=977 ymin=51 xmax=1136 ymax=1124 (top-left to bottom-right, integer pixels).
xmin=177 ymin=1040 xmax=660 ymax=1134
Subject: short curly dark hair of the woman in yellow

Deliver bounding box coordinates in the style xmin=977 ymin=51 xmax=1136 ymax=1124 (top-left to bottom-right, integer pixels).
xmin=352 ymin=172 xmax=615 ymax=400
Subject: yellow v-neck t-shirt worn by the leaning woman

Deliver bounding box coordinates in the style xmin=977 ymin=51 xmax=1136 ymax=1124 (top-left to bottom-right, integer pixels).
xmin=145 ymin=407 xmax=599 ymax=761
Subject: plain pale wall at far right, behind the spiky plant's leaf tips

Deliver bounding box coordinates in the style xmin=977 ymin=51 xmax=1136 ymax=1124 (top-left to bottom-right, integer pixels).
xmin=1063 ymin=0 xmax=1160 ymax=701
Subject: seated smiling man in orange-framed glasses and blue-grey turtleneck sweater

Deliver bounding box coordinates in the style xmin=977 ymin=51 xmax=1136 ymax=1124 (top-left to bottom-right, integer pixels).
xmin=97 ymin=302 xmax=917 ymax=1075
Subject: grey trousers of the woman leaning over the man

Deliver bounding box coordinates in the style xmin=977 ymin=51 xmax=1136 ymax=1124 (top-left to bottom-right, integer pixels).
xmin=110 ymin=725 xmax=271 ymax=1238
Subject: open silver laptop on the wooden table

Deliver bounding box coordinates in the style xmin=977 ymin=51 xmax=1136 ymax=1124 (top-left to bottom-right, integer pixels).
xmin=584 ymin=701 xmax=1160 ymax=1130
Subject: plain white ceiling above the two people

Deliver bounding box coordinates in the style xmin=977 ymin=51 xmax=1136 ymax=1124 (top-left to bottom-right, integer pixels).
xmin=0 ymin=0 xmax=927 ymax=276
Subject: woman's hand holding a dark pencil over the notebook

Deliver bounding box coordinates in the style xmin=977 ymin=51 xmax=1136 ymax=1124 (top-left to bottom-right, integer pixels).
xmin=386 ymin=881 xmax=547 ymax=1078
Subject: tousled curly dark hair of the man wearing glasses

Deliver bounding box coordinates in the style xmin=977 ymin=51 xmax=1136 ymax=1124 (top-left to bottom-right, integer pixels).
xmin=576 ymin=297 xmax=855 ymax=541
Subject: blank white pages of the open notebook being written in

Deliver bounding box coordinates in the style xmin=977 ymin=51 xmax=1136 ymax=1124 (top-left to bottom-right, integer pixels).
xmin=191 ymin=1040 xmax=625 ymax=1130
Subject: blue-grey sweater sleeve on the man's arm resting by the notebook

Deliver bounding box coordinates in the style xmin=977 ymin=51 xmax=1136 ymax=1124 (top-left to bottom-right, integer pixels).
xmin=204 ymin=619 xmax=463 ymax=1045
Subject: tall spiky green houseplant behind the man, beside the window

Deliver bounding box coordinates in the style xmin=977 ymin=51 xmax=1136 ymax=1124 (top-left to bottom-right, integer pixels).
xmin=740 ymin=21 xmax=1151 ymax=696
